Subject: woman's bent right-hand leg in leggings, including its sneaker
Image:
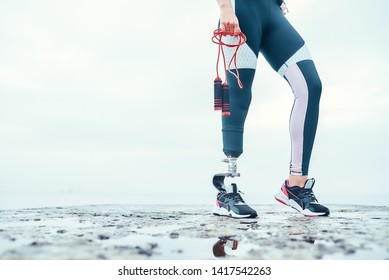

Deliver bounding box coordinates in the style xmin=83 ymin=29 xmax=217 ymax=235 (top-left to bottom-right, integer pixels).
xmin=261 ymin=1 xmax=330 ymax=216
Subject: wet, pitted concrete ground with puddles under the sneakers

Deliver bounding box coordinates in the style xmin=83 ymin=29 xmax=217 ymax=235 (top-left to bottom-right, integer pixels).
xmin=0 ymin=205 xmax=389 ymax=260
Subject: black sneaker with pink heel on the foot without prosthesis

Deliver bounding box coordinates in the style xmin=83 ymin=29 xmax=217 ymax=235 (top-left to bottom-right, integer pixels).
xmin=275 ymin=178 xmax=330 ymax=217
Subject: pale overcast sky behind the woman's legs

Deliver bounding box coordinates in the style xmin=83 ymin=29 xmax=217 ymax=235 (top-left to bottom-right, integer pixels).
xmin=0 ymin=0 xmax=389 ymax=208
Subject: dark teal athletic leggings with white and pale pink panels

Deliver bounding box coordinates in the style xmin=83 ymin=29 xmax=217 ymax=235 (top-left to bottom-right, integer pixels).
xmin=222 ymin=0 xmax=322 ymax=176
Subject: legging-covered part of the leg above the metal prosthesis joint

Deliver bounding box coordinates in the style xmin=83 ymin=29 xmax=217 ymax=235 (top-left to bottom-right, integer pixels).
xmin=222 ymin=0 xmax=264 ymax=158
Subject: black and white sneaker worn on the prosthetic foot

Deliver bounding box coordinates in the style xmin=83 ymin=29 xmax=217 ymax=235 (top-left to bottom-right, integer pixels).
xmin=213 ymin=184 xmax=257 ymax=218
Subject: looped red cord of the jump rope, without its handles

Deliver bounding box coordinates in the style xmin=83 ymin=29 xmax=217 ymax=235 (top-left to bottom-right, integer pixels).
xmin=212 ymin=28 xmax=247 ymax=88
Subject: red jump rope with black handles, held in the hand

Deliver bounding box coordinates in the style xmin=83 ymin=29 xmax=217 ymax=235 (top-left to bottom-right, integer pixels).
xmin=212 ymin=29 xmax=247 ymax=116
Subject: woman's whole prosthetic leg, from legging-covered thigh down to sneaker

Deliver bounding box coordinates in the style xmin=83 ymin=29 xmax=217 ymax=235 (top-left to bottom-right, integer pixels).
xmin=213 ymin=0 xmax=263 ymax=218
